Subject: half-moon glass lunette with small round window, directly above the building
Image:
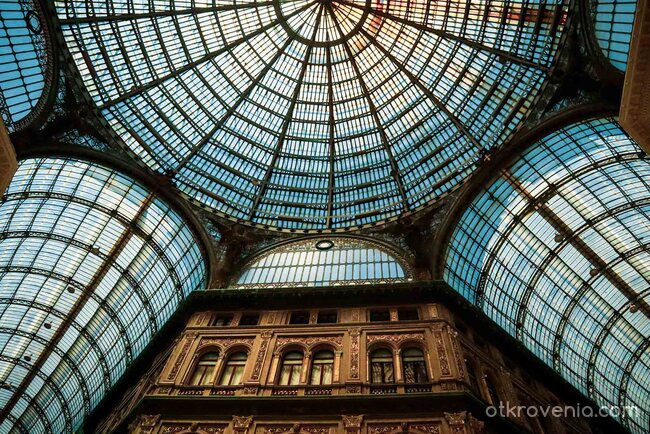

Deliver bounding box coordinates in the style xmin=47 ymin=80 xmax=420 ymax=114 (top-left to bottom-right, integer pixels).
xmin=235 ymin=237 xmax=413 ymax=288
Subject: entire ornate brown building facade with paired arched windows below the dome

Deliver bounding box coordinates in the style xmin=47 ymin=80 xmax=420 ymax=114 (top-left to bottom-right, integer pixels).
xmin=88 ymin=282 xmax=620 ymax=434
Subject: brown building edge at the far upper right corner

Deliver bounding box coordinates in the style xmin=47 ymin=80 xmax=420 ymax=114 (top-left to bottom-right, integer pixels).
xmin=619 ymin=1 xmax=650 ymax=153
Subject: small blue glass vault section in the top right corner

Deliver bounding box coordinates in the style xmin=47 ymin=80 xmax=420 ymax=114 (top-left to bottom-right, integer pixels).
xmin=593 ymin=0 xmax=636 ymax=71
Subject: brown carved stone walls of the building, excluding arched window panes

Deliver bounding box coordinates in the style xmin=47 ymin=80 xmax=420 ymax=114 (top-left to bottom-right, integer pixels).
xmin=93 ymin=303 xmax=592 ymax=434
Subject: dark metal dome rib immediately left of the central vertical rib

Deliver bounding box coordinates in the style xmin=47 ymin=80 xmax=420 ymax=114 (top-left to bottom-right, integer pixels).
xmin=248 ymin=5 xmax=323 ymax=220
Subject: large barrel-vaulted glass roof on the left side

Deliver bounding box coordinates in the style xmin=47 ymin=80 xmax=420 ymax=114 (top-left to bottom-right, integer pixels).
xmin=0 ymin=158 xmax=206 ymax=434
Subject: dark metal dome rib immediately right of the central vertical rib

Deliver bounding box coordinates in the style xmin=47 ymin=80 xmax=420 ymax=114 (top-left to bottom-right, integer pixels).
xmin=325 ymin=3 xmax=410 ymax=211
